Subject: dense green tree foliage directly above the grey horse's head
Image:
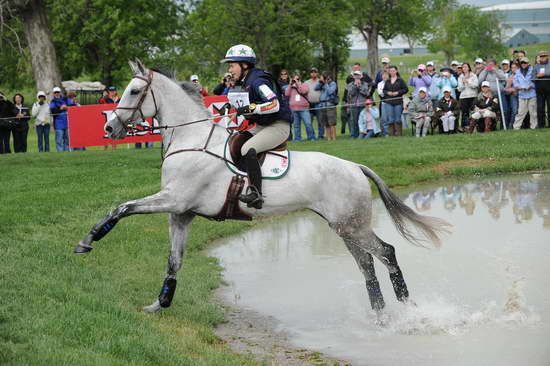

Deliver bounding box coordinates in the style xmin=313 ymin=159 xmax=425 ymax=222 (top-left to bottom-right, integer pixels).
xmin=48 ymin=0 xmax=178 ymax=85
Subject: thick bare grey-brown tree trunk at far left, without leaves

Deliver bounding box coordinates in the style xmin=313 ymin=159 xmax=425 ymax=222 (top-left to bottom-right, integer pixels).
xmin=21 ymin=0 xmax=61 ymax=93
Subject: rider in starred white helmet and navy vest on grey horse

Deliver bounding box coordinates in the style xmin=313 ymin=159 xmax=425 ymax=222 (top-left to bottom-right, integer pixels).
xmin=221 ymin=44 xmax=291 ymax=209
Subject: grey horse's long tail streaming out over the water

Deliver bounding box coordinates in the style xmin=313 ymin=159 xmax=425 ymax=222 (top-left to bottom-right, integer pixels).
xmin=359 ymin=165 xmax=452 ymax=248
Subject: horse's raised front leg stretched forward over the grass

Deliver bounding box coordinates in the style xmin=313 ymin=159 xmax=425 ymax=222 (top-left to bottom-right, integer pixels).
xmin=74 ymin=192 xmax=175 ymax=254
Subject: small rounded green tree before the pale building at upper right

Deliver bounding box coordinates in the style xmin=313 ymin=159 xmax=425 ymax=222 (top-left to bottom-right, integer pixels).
xmin=427 ymin=5 xmax=506 ymax=63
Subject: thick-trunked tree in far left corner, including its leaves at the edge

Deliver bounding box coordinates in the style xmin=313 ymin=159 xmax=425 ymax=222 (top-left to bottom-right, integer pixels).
xmin=0 ymin=0 xmax=61 ymax=90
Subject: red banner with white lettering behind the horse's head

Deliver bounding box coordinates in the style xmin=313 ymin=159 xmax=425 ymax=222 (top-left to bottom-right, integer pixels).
xmin=68 ymin=96 xmax=232 ymax=147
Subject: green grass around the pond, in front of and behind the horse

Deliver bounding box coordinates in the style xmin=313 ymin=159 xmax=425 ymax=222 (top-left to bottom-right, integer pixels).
xmin=0 ymin=130 xmax=550 ymax=365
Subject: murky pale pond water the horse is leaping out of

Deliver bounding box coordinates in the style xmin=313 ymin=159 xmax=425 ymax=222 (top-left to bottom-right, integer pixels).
xmin=212 ymin=174 xmax=550 ymax=366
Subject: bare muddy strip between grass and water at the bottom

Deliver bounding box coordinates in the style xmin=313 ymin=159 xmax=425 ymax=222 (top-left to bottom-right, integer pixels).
xmin=214 ymin=289 xmax=351 ymax=366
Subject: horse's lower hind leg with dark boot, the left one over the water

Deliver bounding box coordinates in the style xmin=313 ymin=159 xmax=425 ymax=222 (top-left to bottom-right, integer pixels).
xmin=344 ymin=240 xmax=386 ymax=312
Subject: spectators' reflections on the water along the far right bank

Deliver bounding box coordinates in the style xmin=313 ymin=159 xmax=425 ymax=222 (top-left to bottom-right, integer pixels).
xmin=409 ymin=174 xmax=550 ymax=229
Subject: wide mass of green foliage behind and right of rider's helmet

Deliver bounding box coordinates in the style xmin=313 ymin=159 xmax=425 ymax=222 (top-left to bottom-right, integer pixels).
xmin=182 ymin=0 xmax=349 ymax=81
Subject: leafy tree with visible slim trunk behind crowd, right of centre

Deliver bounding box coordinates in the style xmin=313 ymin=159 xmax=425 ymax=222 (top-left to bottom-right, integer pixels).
xmin=350 ymin=0 xmax=427 ymax=75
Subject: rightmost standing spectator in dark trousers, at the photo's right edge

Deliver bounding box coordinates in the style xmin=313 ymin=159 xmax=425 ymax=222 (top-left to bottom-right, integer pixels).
xmin=533 ymin=51 xmax=550 ymax=128
